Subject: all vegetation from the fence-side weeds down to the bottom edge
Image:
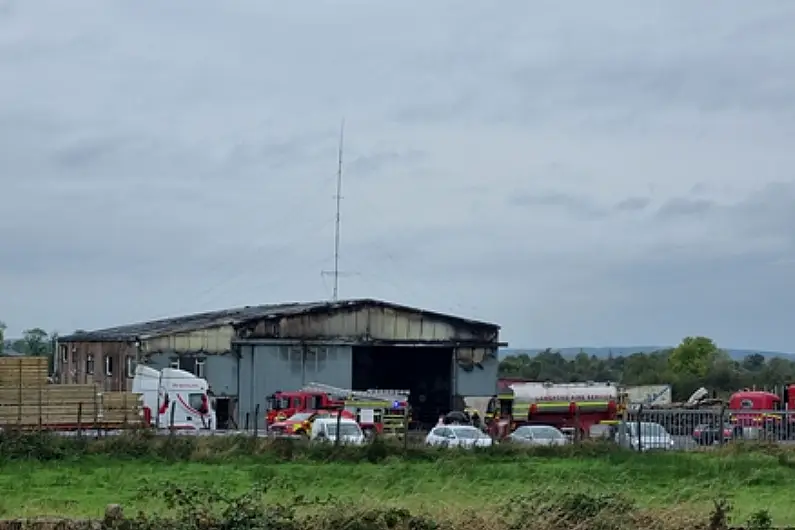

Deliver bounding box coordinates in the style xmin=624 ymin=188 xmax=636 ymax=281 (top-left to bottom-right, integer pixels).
xmin=0 ymin=432 xmax=795 ymax=530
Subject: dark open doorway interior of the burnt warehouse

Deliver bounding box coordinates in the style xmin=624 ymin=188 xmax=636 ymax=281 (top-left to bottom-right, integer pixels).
xmin=353 ymin=346 xmax=453 ymax=428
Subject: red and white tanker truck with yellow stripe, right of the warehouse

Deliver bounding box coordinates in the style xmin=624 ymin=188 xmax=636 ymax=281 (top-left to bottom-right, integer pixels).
xmin=486 ymin=382 xmax=626 ymax=439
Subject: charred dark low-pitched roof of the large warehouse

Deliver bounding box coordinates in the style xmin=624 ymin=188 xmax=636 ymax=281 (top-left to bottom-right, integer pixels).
xmin=58 ymin=298 xmax=500 ymax=342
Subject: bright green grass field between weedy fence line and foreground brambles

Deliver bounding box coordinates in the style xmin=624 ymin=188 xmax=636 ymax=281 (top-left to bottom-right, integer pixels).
xmin=0 ymin=444 xmax=795 ymax=524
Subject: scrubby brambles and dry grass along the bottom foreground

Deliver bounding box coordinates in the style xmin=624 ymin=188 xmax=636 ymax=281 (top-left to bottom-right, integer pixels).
xmin=106 ymin=482 xmax=740 ymax=530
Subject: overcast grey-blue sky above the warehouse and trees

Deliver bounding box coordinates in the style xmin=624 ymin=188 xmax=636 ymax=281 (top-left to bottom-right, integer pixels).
xmin=0 ymin=0 xmax=795 ymax=351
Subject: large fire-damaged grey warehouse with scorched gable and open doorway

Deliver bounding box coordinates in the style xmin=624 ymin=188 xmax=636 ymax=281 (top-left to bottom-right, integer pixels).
xmin=56 ymin=299 xmax=506 ymax=428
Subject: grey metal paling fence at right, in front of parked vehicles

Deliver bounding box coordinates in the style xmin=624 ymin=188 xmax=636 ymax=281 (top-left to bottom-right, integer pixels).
xmin=613 ymin=407 xmax=795 ymax=450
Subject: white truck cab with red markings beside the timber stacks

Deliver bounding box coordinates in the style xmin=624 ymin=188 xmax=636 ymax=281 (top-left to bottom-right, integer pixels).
xmin=132 ymin=364 xmax=215 ymax=431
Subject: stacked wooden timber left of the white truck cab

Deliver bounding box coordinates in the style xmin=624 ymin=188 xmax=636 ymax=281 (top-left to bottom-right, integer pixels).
xmin=0 ymin=357 xmax=141 ymax=428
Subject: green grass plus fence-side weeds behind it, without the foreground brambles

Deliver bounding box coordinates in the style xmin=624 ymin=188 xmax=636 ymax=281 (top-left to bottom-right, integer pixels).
xmin=0 ymin=436 xmax=795 ymax=528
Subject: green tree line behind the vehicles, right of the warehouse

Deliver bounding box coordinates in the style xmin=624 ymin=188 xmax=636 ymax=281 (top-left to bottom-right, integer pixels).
xmin=499 ymin=337 xmax=795 ymax=401
